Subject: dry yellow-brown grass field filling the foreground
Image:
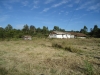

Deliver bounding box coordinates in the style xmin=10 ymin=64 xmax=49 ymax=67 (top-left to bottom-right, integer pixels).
xmin=0 ymin=38 xmax=100 ymax=75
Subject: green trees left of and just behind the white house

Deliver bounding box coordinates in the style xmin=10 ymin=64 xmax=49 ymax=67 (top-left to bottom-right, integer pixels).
xmin=0 ymin=24 xmax=65 ymax=39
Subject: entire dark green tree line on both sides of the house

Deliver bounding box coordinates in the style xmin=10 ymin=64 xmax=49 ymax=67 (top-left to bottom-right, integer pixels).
xmin=0 ymin=24 xmax=100 ymax=39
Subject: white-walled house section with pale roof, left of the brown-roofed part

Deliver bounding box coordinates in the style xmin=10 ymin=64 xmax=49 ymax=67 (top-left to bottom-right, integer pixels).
xmin=49 ymin=31 xmax=71 ymax=39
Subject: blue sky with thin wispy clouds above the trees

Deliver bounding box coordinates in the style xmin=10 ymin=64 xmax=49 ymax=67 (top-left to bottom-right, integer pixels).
xmin=0 ymin=0 xmax=100 ymax=30
